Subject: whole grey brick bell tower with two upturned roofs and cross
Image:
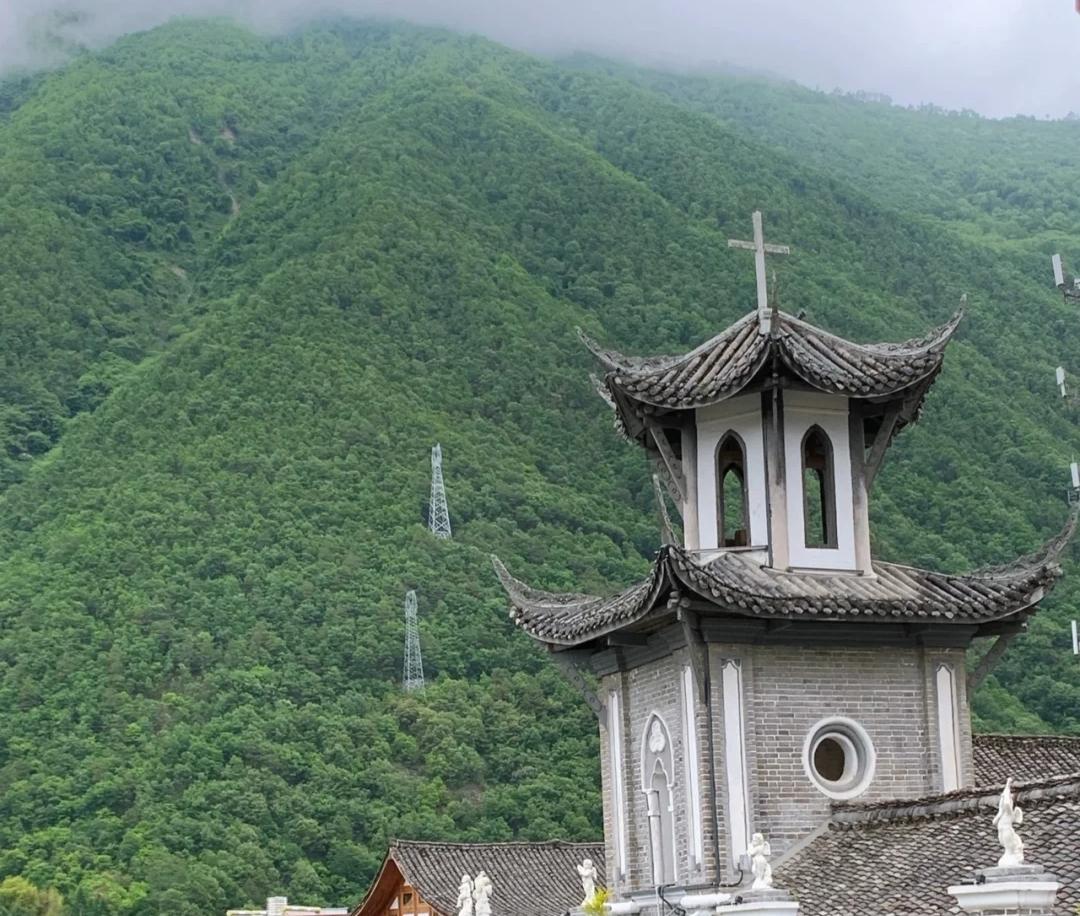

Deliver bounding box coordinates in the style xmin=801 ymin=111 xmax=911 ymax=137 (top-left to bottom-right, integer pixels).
xmin=495 ymin=214 xmax=1076 ymax=913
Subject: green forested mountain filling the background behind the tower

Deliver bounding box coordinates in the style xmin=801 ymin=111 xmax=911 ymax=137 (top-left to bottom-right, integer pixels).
xmin=0 ymin=22 xmax=1080 ymax=916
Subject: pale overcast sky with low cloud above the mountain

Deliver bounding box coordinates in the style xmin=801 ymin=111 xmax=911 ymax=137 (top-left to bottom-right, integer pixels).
xmin=0 ymin=0 xmax=1080 ymax=116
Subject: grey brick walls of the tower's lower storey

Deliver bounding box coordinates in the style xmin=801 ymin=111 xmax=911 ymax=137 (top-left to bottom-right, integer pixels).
xmin=600 ymin=644 xmax=974 ymax=893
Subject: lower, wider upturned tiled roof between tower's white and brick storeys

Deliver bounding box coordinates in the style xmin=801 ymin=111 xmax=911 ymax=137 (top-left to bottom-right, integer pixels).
xmin=492 ymin=512 xmax=1077 ymax=648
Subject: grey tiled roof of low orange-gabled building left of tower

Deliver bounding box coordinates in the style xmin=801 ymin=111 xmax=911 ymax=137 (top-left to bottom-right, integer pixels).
xmin=369 ymin=839 xmax=605 ymax=916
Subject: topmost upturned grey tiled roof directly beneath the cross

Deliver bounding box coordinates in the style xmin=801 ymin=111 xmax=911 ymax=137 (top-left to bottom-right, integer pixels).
xmin=581 ymin=309 xmax=963 ymax=436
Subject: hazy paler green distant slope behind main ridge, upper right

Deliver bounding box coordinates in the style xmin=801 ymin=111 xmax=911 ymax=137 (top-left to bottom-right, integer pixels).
xmin=567 ymin=56 xmax=1080 ymax=247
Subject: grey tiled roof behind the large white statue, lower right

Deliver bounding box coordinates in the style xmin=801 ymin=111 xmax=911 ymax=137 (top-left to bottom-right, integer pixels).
xmin=775 ymin=773 xmax=1080 ymax=916
